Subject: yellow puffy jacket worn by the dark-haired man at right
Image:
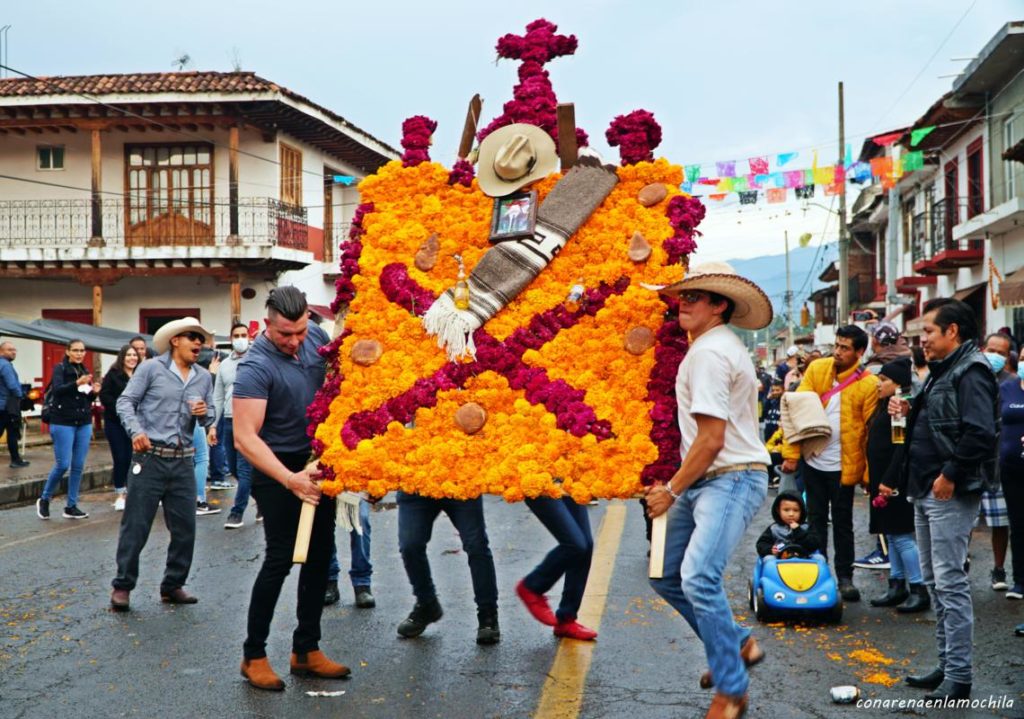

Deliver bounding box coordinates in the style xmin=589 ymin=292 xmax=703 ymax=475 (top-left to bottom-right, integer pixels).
xmin=782 ymin=357 xmax=879 ymax=487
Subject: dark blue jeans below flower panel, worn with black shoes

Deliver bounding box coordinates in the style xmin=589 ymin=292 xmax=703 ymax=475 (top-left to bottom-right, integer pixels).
xmin=398 ymin=492 xmax=498 ymax=610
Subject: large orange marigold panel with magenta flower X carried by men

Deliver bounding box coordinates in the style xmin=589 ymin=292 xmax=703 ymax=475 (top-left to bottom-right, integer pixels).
xmin=309 ymin=19 xmax=703 ymax=502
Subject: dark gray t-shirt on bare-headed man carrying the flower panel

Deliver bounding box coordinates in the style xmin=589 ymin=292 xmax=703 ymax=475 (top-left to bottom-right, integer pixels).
xmin=233 ymin=323 xmax=331 ymax=453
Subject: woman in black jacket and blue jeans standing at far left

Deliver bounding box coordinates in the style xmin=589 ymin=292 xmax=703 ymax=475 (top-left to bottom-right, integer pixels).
xmin=36 ymin=339 xmax=99 ymax=519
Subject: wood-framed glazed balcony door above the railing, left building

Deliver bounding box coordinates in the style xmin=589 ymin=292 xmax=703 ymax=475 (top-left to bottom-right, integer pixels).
xmin=126 ymin=144 xmax=213 ymax=225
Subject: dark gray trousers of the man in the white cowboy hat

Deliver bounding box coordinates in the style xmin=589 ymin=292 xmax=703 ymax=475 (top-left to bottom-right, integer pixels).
xmin=111 ymin=454 xmax=196 ymax=592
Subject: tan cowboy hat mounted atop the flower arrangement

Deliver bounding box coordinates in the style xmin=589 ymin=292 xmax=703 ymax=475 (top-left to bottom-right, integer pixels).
xmin=477 ymin=123 xmax=558 ymax=198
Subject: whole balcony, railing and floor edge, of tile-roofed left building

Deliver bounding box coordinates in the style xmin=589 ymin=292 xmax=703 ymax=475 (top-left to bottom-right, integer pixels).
xmin=0 ymin=198 xmax=319 ymax=281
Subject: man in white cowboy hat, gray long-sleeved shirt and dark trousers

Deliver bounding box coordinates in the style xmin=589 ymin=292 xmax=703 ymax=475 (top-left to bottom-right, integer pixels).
xmin=111 ymin=318 xmax=217 ymax=611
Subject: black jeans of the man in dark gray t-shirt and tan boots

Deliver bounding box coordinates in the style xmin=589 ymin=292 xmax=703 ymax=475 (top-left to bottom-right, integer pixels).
xmin=241 ymin=453 xmax=336 ymax=660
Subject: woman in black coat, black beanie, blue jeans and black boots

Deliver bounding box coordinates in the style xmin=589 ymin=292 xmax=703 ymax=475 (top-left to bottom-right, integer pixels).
xmin=867 ymin=357 xmax=931 ymax=614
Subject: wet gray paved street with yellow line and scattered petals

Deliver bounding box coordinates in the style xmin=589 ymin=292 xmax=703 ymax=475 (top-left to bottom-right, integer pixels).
xmin=0 ymin=492 xmax=1024 ymax=719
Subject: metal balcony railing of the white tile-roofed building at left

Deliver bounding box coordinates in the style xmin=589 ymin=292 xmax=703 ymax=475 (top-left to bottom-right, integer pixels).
xmin=0 ymin=198 xmax=308 ymax=250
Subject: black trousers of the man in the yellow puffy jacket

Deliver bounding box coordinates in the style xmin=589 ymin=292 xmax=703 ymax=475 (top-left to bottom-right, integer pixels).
xmin=800 ymin=462 xmax=854 ymax=580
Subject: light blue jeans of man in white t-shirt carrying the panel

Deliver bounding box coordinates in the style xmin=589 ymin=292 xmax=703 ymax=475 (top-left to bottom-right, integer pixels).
xmin=650 ymin=470 xmax=768 ymax=696
